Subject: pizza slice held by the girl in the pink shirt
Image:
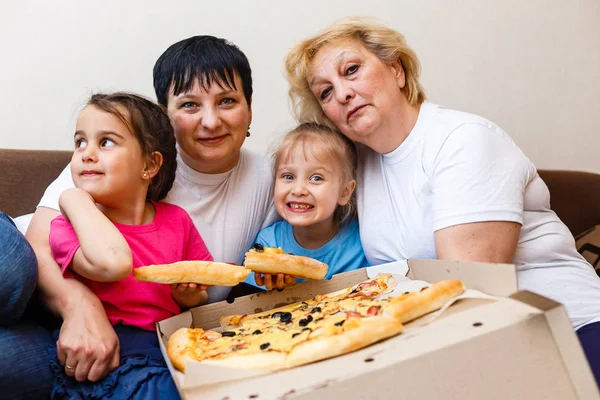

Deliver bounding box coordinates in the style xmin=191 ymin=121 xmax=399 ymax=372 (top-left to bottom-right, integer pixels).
xmin=133 ymin=261 xmax=251 ymax=286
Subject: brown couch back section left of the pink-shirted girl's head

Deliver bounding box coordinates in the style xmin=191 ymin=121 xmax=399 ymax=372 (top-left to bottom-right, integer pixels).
xmin=0 ymin=149 xmax=73 ymax=217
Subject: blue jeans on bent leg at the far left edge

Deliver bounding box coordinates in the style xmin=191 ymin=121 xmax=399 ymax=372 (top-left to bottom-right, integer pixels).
xmin=0 ymin=212 xmax=52 ymax=399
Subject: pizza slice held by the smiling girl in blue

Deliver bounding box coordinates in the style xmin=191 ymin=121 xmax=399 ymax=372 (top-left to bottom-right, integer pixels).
xmin=244 ymin=243 xmax=328 ymax=280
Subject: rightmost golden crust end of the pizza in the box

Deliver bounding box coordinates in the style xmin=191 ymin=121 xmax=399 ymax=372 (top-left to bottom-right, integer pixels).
xmin=385 ymin=280 xmax=465 ymax=323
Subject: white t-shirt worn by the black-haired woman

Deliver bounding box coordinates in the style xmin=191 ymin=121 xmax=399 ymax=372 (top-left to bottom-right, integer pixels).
xmin=38 ymin=149 xmax=278 ymax=302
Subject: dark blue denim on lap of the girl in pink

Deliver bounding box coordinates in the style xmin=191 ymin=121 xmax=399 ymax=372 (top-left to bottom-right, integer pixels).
xmin=49 ymin=325 xmax=179 ymax=400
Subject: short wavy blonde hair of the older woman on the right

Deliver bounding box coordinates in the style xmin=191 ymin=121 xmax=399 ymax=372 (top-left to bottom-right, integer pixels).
xmin=285 ymin=17 xmax=425 ymax=128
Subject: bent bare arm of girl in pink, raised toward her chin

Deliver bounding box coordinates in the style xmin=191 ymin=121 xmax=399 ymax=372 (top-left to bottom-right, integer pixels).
xmin=59 ymin=189 xmax=133 ymax=282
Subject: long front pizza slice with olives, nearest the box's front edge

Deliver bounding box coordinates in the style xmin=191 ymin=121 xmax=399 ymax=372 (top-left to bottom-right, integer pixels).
xmin=167 ymin=313 xmax=402 ymax=371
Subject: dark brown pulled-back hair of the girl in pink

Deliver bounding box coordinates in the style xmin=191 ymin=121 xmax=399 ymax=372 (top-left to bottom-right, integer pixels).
xmin=87 ymin=92 xmax=177 ymax=201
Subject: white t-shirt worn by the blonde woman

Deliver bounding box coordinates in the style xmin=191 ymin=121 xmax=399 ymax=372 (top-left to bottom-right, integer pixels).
xmin=357 ymin=102 xmax=600 ymax=329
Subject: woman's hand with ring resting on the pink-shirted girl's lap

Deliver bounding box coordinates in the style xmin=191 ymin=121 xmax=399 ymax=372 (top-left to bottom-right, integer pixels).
xmin=56 ymin=279 xmax=120 ymax=382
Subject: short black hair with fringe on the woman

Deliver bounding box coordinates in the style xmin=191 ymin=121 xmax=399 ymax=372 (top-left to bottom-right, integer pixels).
xmin=153 ymin=35 xmax=252 ymax=107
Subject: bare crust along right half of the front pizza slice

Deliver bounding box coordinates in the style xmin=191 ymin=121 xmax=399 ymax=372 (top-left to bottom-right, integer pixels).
xmin=285 ymin=316 xmax=402 ymax=368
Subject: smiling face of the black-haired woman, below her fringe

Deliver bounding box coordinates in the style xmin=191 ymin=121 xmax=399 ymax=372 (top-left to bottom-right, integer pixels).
xmin=167 ymin=75 xmax=252 ymax=174
